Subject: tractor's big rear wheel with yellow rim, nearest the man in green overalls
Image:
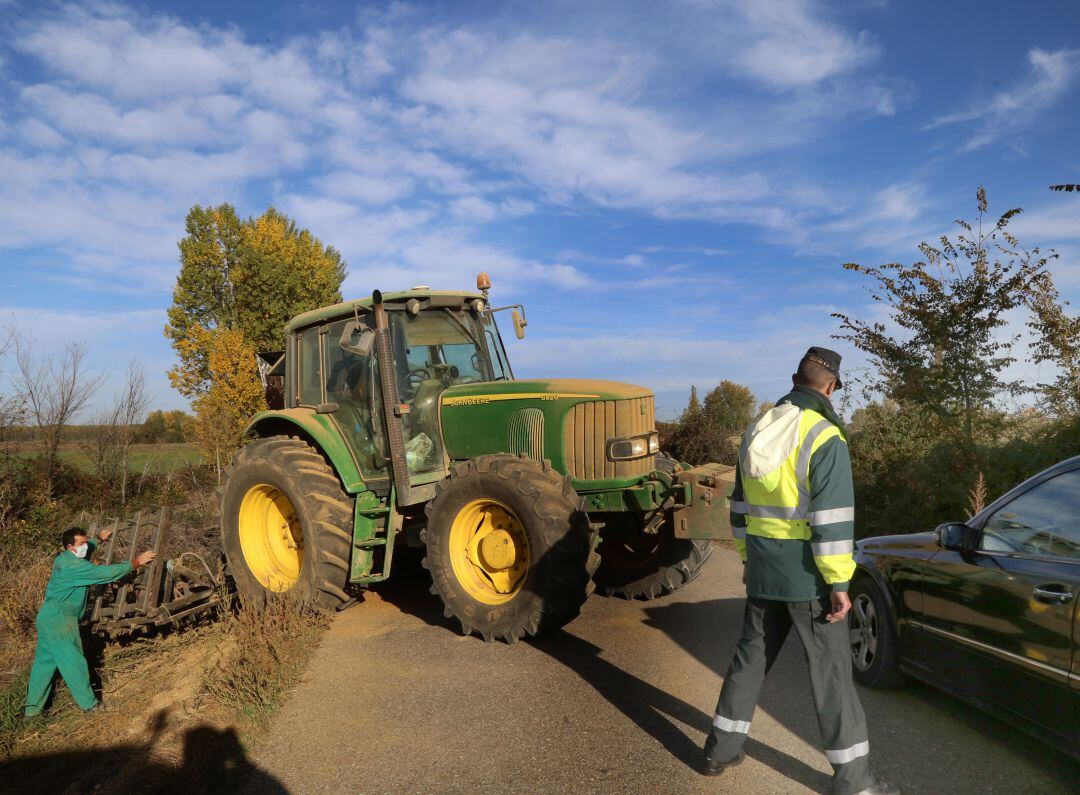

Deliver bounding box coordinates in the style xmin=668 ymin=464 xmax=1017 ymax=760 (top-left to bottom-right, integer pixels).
xmin=218 ymin=436 xmax=353 ymax=611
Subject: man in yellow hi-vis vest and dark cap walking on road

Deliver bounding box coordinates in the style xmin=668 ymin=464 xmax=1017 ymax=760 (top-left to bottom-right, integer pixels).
xmin=703 ymin=348 xmax=900 ymax=795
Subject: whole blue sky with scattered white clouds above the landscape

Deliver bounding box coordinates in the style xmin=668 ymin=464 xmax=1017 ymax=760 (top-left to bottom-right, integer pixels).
xmin=0 ymin=0 xmax=1080 ymax=416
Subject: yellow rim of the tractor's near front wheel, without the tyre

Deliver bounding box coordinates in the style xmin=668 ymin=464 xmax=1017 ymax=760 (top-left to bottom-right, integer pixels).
xmin=450 ymin=500 xmax=529 ymax=605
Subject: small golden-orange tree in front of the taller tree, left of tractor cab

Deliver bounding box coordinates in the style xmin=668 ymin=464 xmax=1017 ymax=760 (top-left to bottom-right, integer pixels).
xmin=192 ymin=328 xmax=266 ymax=481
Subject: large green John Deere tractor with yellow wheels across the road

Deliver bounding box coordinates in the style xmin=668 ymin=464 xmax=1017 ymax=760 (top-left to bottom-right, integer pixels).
xmin=219 ymin=274 xmax=732 ymax=643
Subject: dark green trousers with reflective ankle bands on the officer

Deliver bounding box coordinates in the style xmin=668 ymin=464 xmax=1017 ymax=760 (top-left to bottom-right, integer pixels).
xmin=705 ymin=598 xmax=874 ymax=795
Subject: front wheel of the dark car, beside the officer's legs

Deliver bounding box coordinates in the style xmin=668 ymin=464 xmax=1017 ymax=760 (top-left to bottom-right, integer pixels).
xmin=848 ymin=577 xmax=905 ymax=688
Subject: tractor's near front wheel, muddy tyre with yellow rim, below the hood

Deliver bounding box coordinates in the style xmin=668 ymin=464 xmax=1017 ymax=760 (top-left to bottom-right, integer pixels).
xmin=420 ymin=456 xmax=599 ymax=643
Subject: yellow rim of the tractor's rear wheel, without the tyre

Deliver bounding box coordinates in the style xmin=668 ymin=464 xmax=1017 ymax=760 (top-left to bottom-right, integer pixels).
xmin=240 ymin=483 xmax=303 ymax=592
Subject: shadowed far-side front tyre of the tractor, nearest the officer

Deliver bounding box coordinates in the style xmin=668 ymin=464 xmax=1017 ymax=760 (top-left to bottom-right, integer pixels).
xmin=596 ymin=522 xmax=713 ymax=599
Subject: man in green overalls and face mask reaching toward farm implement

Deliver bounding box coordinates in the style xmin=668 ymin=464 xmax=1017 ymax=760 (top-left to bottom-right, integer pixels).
xmin=26 ymin=527 xmax=154 ymax=717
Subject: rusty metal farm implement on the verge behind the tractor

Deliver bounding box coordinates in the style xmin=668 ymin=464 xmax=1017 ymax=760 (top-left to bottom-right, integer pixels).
xmin=89 ymin=507 xmax=224 ymax=635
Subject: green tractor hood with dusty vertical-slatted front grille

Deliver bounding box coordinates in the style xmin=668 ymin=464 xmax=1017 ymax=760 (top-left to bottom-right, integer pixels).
xmin=441 ymin=378 xmax=656 ymax=483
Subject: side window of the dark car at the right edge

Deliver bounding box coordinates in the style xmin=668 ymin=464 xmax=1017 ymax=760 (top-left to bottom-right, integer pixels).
xmin=980 ymin=470 xmax=1080 ymax=561
